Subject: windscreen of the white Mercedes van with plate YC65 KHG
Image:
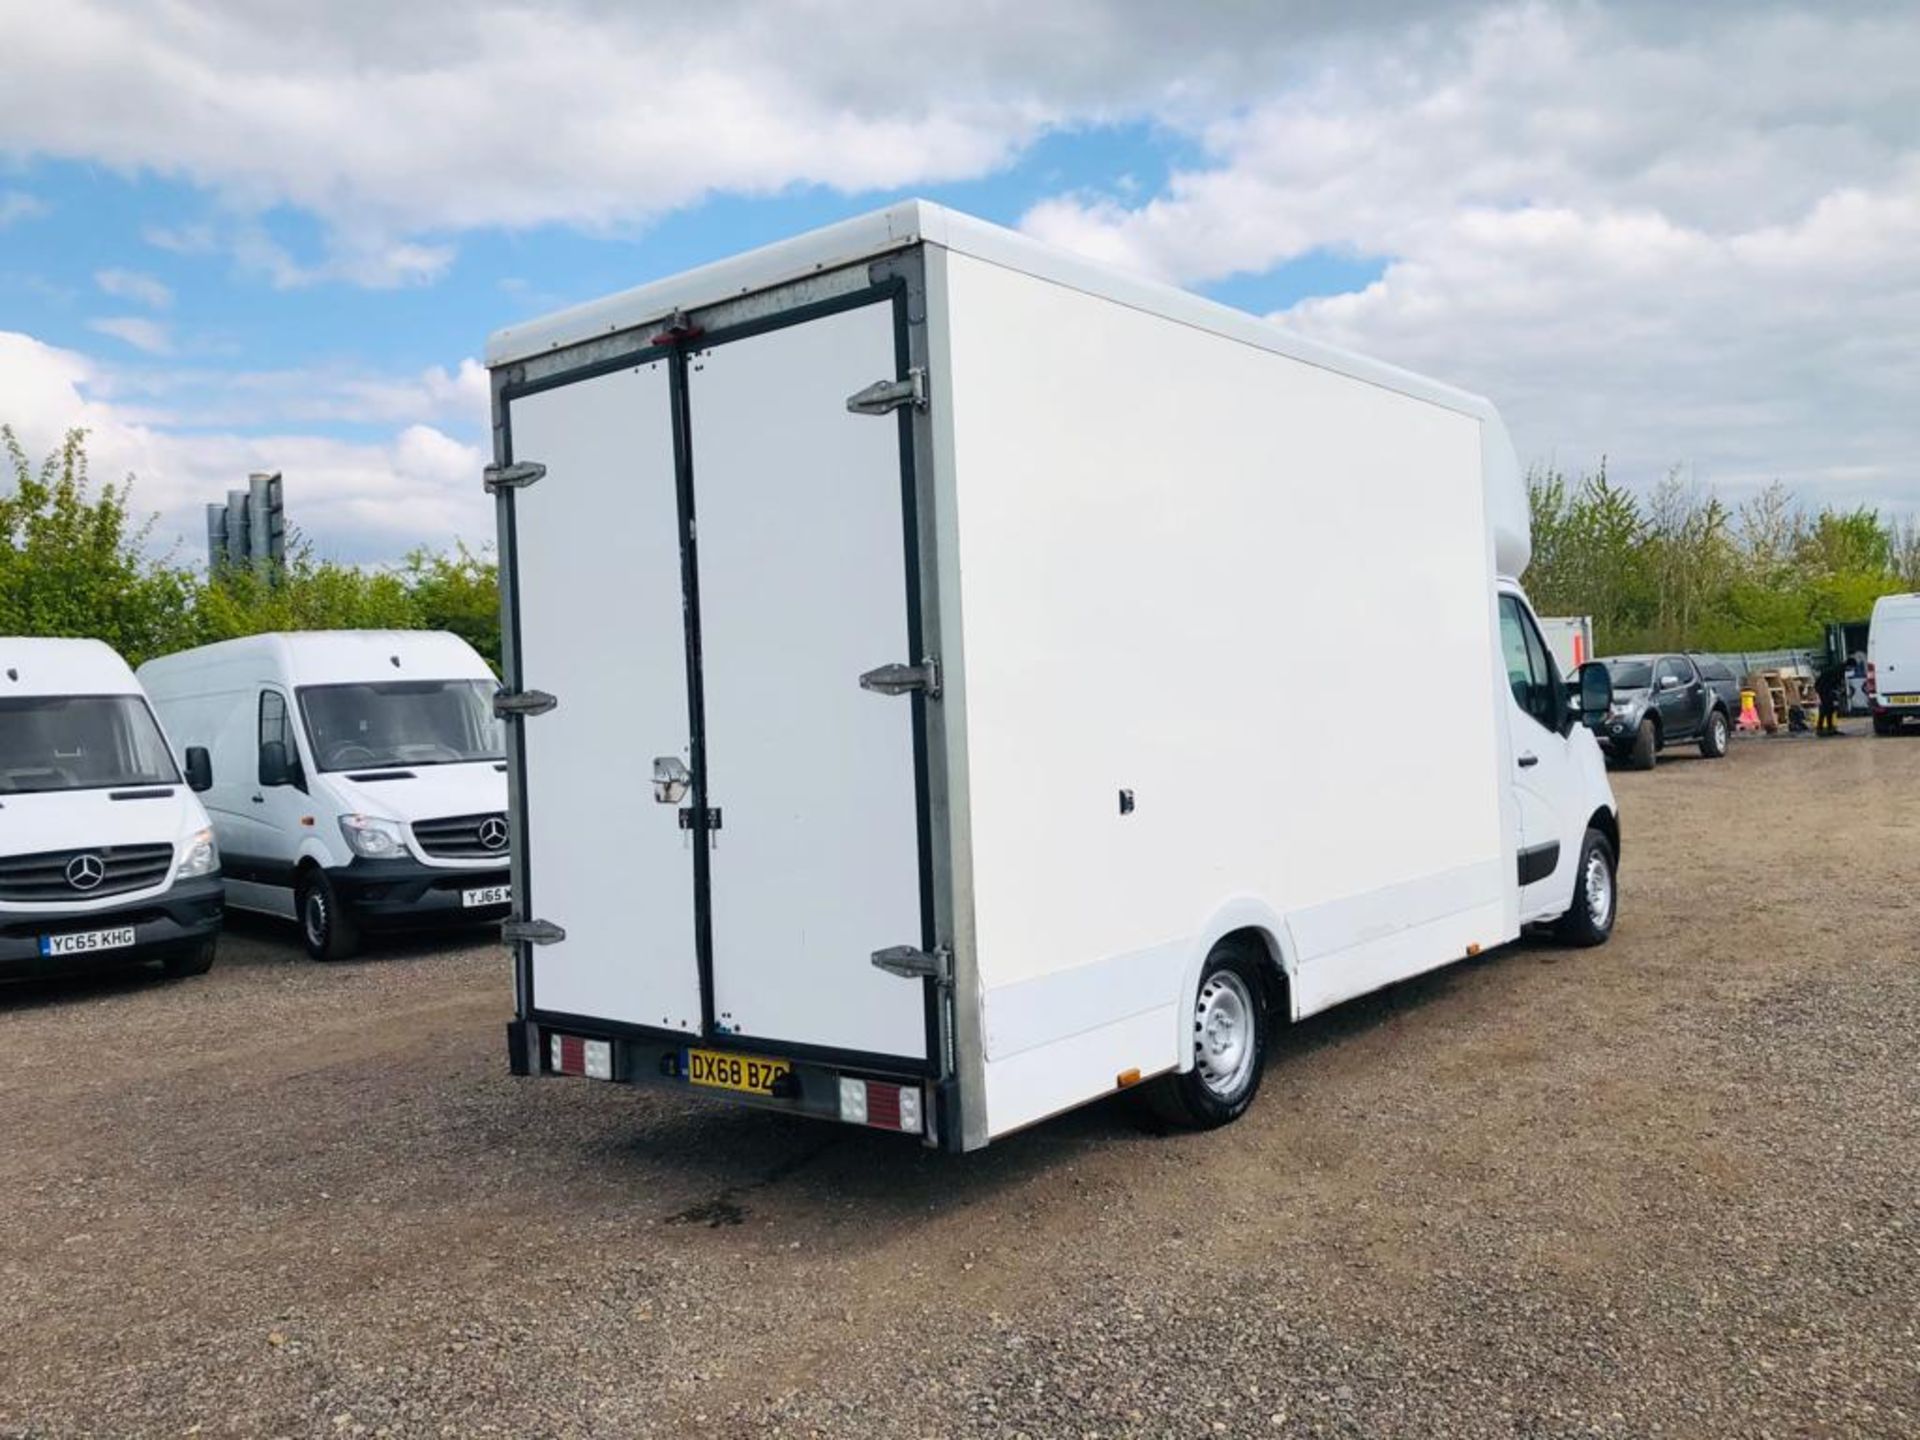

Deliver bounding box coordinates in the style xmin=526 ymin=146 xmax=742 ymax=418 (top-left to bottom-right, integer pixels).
xmin=0 ymin=695 xmax=180 ymax=795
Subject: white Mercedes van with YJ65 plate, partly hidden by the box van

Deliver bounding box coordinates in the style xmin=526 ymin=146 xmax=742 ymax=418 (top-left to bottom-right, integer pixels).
xmin=140 ymin=630 xmax=511 ymax=960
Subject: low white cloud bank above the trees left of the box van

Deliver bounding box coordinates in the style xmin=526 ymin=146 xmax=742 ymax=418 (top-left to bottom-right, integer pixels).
xmin=0 ymin=332 xmax=493 ymax=563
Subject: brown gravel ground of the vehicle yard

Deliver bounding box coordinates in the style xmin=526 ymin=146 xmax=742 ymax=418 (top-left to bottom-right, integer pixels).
xmin=0 ymin=722 xmax=1920 ymax=1440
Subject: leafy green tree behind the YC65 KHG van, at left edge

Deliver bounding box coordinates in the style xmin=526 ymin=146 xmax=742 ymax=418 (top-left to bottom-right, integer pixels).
xmin=0 ymin=426 xmax=196 ymax=664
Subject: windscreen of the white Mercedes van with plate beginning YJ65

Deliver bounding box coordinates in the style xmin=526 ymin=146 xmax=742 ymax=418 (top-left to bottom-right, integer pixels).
xmin=300 ymin=680 xmax=507 ymax=770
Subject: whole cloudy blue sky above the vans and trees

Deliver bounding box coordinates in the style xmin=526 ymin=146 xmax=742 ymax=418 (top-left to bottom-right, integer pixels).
xmin=0 ymin=0 xmax=1920 ymax=563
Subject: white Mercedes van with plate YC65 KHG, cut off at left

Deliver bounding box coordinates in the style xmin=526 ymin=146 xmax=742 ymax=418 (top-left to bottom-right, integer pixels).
xmin=0 ymin=637 xmax=221 ymax=977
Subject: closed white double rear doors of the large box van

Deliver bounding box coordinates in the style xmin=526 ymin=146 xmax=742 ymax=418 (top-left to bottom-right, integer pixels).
xmin=499 ymin=284 xmax=933 ymax=1069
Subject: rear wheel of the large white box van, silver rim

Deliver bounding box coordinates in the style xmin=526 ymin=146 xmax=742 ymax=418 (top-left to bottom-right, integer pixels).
xmin=1142 ymin=941 xmax=1267 ymax=1131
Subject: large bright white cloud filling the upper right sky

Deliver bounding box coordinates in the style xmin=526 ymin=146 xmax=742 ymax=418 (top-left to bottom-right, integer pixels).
xmin=1025 ymin=6 xmax=1920 ymax=509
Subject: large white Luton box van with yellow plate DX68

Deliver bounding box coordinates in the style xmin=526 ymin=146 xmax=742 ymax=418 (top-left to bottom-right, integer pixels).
xmin=488 ymin=202 xmax=1620 ymax=1150
